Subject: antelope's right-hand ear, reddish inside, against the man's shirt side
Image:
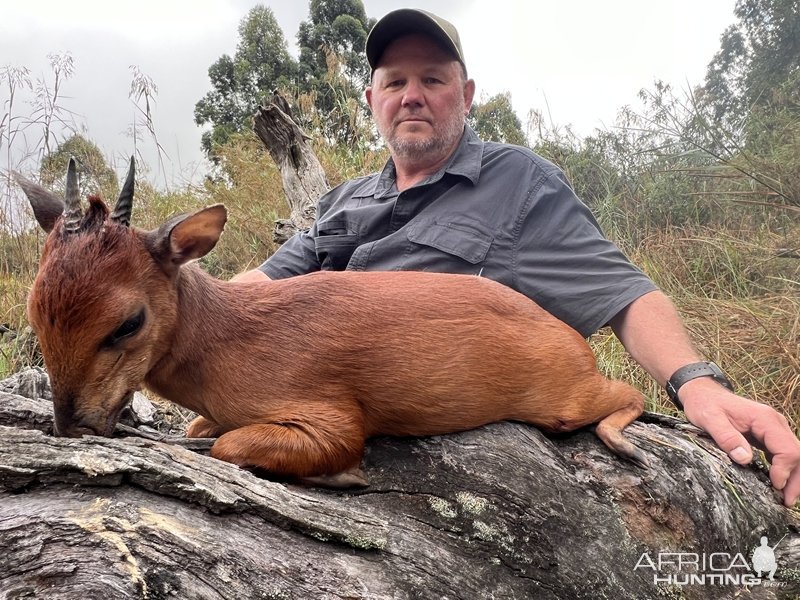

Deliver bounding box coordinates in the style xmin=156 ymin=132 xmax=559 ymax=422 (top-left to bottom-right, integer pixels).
xmin=145 ymin=204 xmax=228 ymax=271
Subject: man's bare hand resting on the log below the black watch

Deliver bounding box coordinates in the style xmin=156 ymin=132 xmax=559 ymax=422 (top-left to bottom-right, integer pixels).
xmin=679 ymin=377 xmax=800 ymax=506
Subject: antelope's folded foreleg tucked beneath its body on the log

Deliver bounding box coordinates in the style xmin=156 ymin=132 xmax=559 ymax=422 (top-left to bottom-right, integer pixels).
xmin=211 ymin=409 xmax=366 ymax=487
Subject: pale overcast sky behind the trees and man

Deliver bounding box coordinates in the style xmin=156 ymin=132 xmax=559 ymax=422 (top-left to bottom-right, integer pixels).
xmin=0 ymin=0 xmax=735 ymax=186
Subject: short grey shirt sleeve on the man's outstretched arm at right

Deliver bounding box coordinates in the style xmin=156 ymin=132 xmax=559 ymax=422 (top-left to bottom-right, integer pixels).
xmin=515 ymin=169 xmax=657 ymax=337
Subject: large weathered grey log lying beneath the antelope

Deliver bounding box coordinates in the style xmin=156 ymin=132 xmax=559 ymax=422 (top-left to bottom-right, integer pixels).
xmin=0 ymin=368 xmax=800 ymax=600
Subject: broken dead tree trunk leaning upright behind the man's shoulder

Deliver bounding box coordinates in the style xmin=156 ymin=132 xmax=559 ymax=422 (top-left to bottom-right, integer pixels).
xmin=253 ymin=92 xmax=329 ymax=244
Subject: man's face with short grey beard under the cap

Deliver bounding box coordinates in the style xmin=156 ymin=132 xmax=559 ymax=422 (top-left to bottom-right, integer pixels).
xmin=366 ymin=34 xmax=475 ymax=163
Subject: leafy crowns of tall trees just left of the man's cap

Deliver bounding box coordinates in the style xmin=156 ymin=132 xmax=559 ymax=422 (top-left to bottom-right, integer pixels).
xmin=195 ymin=0 xmax=373 ymax=158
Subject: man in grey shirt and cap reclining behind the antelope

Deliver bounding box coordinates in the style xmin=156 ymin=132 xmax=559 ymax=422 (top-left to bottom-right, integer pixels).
xmin=236 ymin=9 xmax=800 ymax=506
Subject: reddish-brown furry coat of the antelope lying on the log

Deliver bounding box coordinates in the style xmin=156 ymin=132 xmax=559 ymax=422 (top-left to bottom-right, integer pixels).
xmin=29 ymin=198 xmax=644 ymax=477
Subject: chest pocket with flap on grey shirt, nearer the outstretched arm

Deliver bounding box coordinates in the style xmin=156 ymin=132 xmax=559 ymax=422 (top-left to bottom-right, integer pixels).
xmin=408 ymin=221 xmax=494 ymax=265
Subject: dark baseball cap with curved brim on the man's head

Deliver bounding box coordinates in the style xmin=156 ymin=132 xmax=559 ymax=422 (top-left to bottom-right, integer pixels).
xmin=367 ymin=8 xmax=466 ymax=71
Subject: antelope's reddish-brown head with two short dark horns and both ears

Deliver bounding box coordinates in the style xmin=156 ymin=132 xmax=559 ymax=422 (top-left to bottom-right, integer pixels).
xmin=14 ymin=158 xmax=226 ymax=437
